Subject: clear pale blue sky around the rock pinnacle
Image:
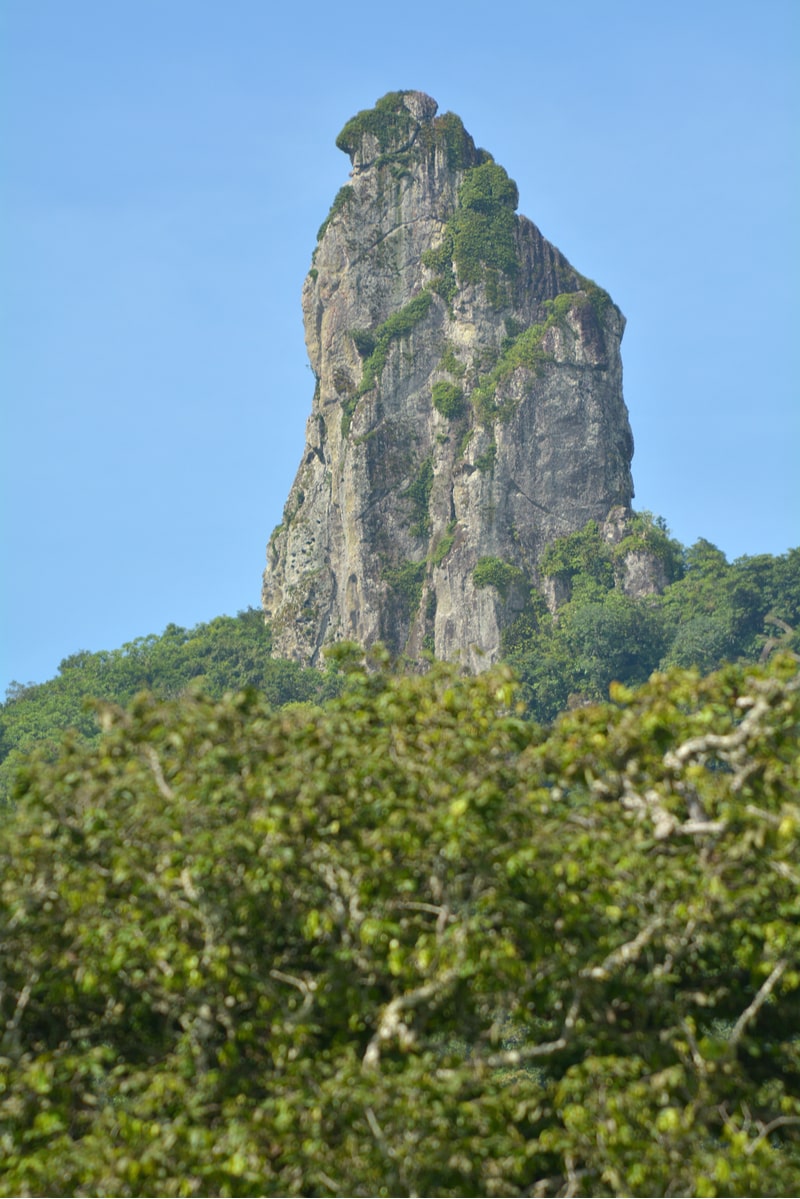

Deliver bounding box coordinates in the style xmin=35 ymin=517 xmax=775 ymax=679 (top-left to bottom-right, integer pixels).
xmin=0 ymin=0 xmax=800 ymax=694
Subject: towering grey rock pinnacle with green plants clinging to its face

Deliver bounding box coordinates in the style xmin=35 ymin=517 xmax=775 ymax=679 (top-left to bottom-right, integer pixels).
xmin=263 ymin=92 xmax=633 ymax=669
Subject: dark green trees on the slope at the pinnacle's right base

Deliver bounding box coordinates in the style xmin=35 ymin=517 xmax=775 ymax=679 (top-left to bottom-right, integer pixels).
xmin=505 ymin=513 xmax=800 ymax=721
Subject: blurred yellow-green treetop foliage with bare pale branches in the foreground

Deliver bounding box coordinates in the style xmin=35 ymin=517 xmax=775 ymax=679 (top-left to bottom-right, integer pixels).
xmin=0 ymin=647 xmax=800 ymax=1195
